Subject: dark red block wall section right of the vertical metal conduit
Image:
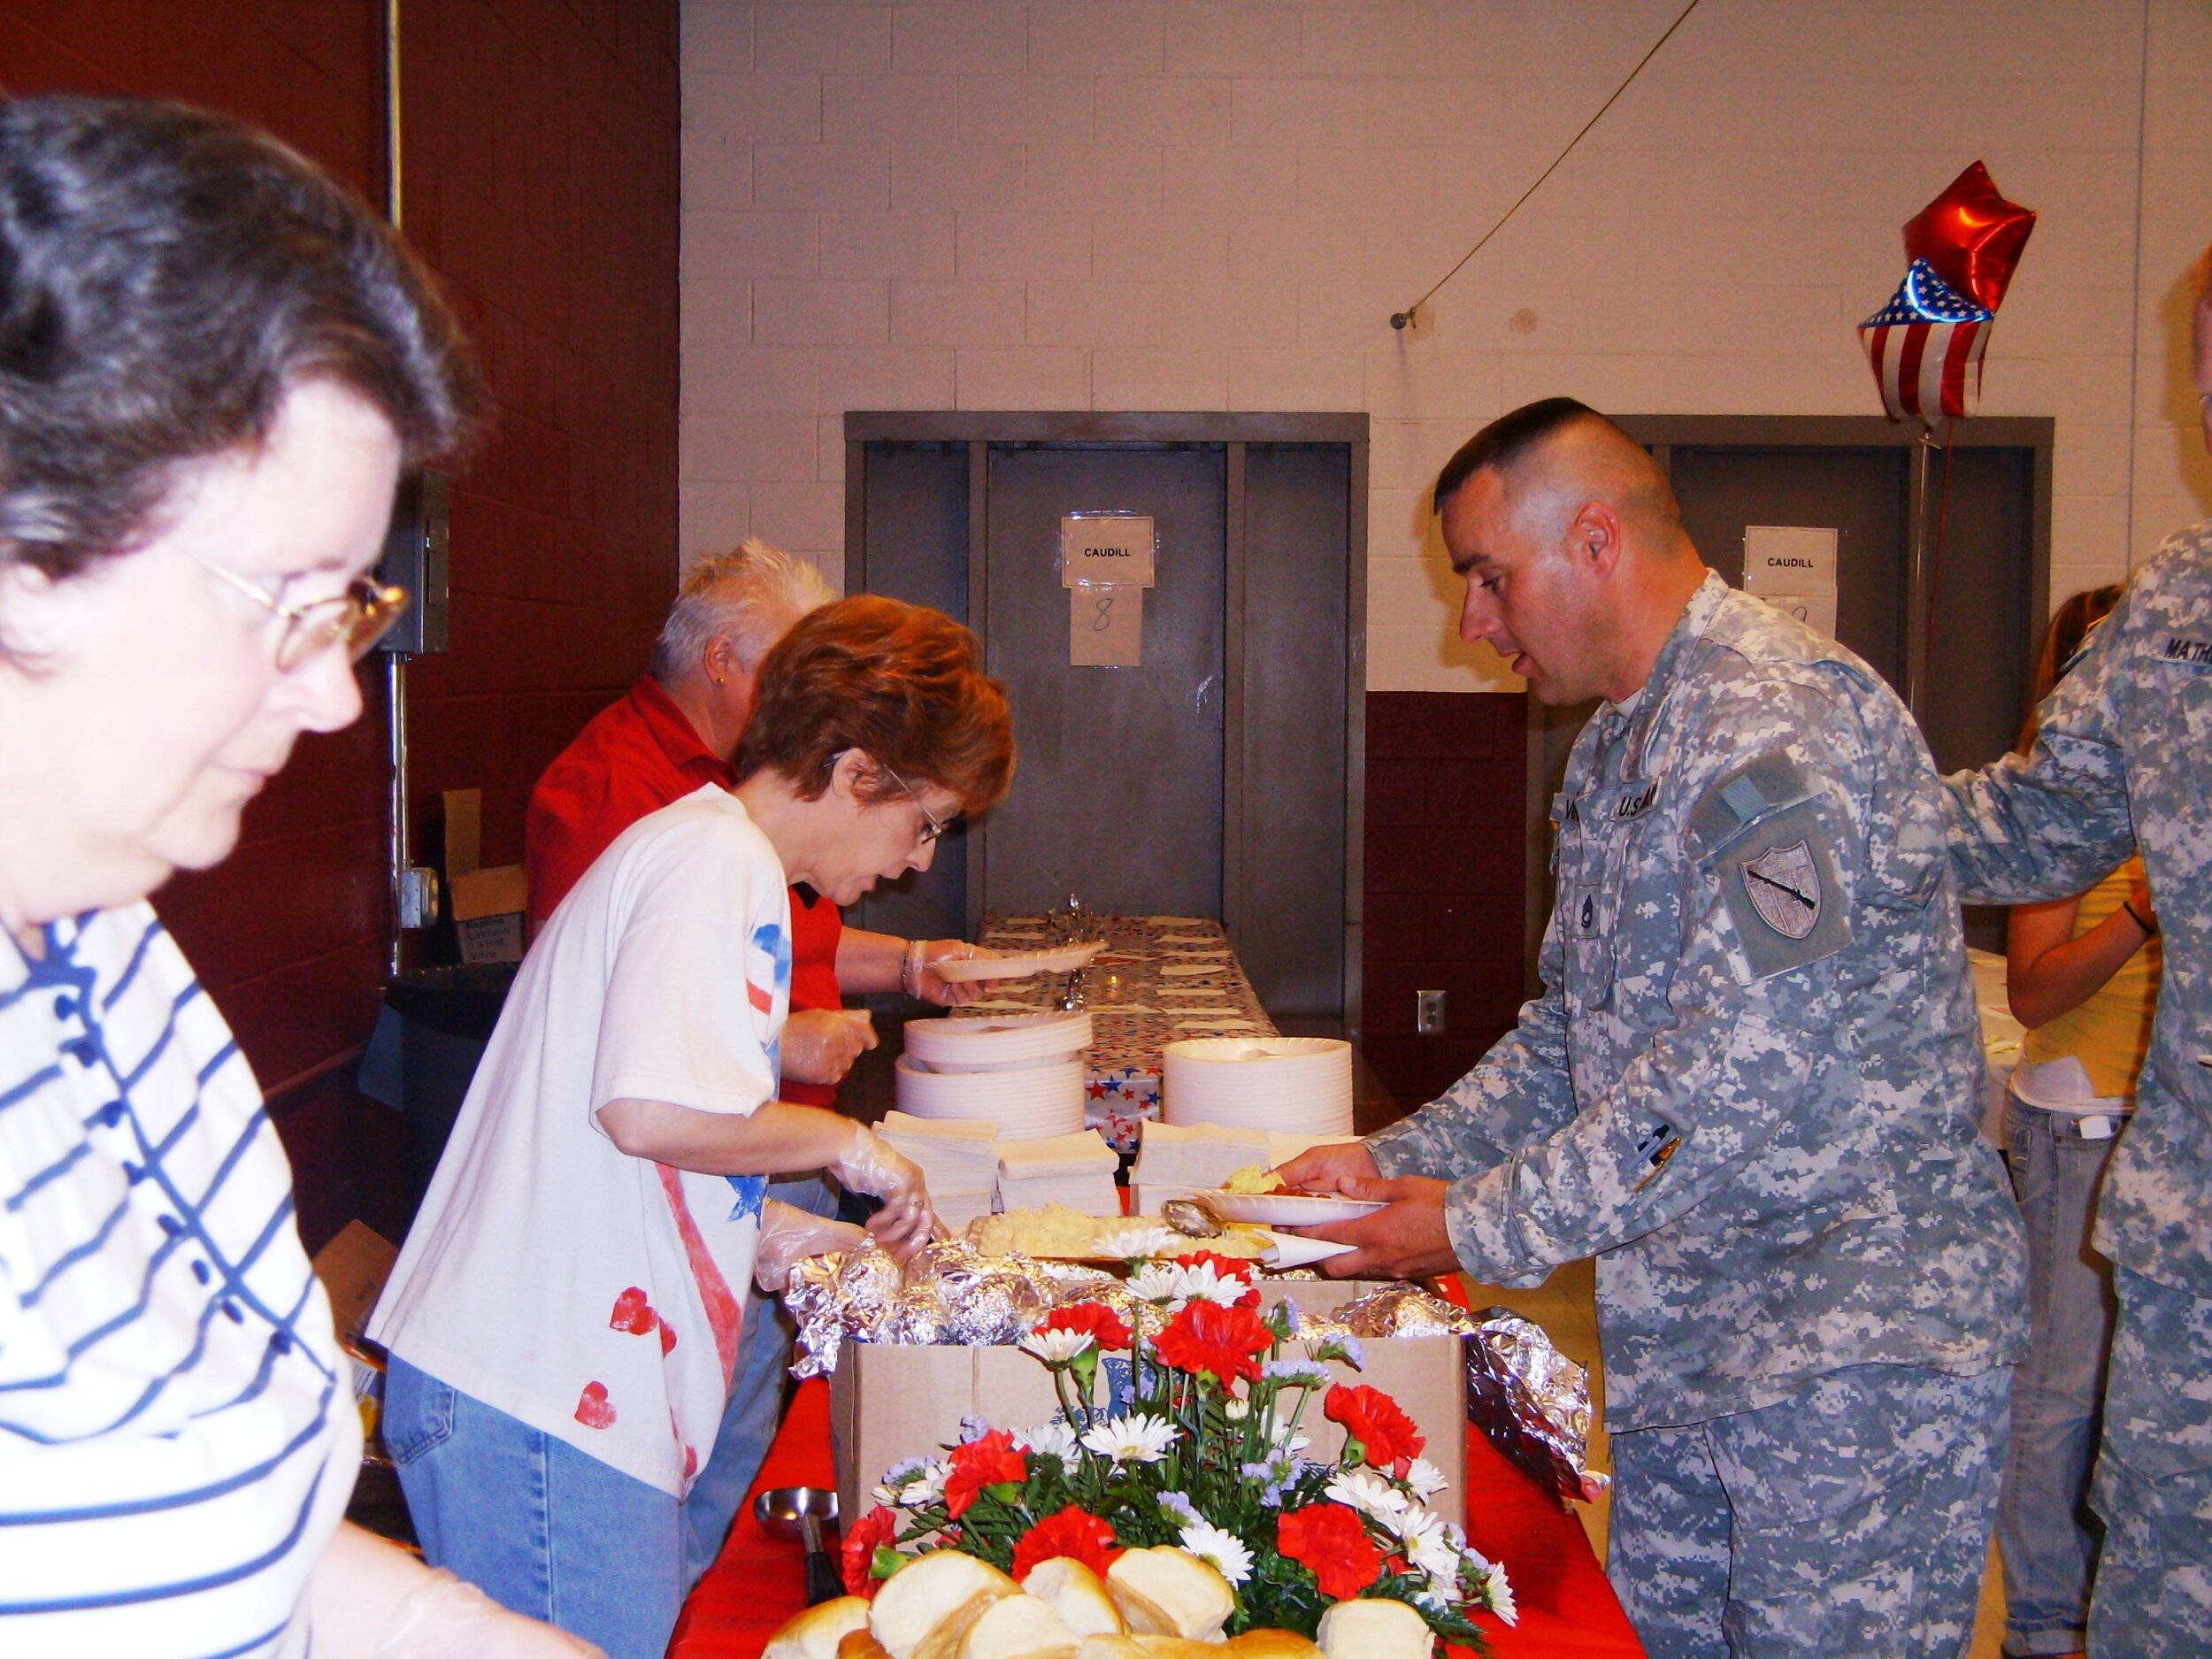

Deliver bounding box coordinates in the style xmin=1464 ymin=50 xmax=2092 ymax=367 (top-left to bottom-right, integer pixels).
xmin=401 ymin=0 xmax=681 ymax=865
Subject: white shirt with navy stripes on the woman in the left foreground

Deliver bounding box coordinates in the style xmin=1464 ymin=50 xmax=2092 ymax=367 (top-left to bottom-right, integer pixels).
xmin=0 ymin=905 xmax=361 ymax=1659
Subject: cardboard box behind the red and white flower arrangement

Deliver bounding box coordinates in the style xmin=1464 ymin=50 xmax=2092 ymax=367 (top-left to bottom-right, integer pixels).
xmin=830 ymin=1279 xmax=1467 ymax=1525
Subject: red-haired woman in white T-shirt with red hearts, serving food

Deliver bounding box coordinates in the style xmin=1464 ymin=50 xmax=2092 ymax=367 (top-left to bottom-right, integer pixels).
xmin=370 ymin=595 xmax=1013 ymax=1659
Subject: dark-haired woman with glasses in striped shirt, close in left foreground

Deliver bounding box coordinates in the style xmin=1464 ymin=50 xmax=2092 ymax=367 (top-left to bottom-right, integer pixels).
xmin=0 ymin=97 xmax=587 ymax=1659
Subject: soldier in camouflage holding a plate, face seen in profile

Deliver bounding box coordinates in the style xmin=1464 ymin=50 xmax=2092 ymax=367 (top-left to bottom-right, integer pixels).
xmin=1286 ymin=398 xmax=2026 ymax=1659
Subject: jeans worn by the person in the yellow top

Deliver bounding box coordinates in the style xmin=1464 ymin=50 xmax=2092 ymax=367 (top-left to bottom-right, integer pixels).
xmin=1998 ymin=1097 xmax=2117 ymax=1659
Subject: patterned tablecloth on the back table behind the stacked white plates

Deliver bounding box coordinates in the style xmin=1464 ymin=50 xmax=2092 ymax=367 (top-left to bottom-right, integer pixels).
xmin=954 ymin=916 xmax=1277 ymax=1153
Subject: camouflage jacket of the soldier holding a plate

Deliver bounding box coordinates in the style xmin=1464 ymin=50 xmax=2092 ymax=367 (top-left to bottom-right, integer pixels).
xmin=1367 ymin=575 xmax=2026 ymax=1429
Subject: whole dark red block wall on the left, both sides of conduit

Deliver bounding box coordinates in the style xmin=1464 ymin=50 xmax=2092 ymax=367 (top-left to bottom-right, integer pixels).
xmin=0 ymin=0 xmax=680 ymax=1246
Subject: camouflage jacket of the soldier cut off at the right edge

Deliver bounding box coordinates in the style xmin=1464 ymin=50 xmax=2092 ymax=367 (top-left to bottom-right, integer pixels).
xmin=1945 ymin=520 xmax=2212 ymax=1299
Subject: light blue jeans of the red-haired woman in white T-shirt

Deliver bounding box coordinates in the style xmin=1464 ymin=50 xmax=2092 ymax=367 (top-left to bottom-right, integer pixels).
xmin=385 ymin=1358 xmax=684 ymax=1659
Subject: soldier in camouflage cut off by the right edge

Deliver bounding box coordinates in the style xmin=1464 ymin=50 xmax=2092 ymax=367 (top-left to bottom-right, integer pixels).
xmin=1945 ymin=248 xmax=2212 ymax=1659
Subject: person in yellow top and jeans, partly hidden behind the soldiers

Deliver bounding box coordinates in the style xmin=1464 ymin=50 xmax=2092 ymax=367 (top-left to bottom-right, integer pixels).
xmin=1998 ymin=587 xmax=2159 ymax=1659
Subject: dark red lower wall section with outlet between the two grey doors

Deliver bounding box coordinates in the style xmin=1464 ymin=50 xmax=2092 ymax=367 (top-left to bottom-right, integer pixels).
xmin=1361 ymin=693 xmax=1529 ymax=1109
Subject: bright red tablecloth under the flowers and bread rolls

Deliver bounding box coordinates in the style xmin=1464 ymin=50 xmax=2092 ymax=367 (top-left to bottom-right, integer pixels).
xmin=668 ymin=1383 xmax=1644 ymax=1659
